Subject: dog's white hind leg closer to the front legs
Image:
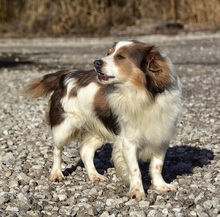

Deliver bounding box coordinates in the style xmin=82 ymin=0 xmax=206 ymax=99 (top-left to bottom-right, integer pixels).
xmin=80 ymin=136 xmax=107 ymax=182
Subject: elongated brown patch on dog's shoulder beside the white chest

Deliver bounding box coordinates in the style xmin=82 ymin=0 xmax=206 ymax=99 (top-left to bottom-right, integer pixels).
xmin=94 ymin=86 xmax=120 ymax=135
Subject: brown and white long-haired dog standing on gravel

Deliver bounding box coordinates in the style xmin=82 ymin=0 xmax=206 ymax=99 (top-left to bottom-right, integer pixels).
xmin=22 ymin=40 xmax=181 ymax=200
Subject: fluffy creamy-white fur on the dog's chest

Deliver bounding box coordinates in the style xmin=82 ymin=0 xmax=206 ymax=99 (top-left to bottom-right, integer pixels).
xmin=109 ymin=83 xmax=181 ymax=146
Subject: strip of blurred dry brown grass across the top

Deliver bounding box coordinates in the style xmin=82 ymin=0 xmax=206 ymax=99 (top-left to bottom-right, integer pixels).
xmin=0 ymin=0 xmax=220 ymax=37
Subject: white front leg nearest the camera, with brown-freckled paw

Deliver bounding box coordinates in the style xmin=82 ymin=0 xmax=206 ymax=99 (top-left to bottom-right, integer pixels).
xmin=122 ymin=140 xmax=145 ymax=201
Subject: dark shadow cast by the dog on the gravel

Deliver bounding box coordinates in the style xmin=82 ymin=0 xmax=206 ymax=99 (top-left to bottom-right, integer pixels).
xmin=64 ymin=144 xmax=214 ymax=188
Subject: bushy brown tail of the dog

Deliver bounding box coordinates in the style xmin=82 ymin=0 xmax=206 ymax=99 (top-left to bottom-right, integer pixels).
xmin=20 ymin=70 xmax=68 ymax=98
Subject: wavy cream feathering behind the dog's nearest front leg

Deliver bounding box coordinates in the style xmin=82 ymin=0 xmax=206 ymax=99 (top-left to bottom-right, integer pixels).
xmin=112 ymin=141 xmax=129 ymax=184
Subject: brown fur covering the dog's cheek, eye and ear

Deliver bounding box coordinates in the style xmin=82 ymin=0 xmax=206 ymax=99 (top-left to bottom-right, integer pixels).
xmin=114 ymin=40 xmax=171 ymax=96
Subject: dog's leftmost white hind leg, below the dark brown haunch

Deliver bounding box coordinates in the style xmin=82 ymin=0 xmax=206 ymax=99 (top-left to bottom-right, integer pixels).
xmin=50 ymin=120 xmax=74 ymax=182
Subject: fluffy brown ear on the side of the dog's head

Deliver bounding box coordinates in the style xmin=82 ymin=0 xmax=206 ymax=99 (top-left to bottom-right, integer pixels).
xmin=146 ymin=47 xmax=171 ymax=95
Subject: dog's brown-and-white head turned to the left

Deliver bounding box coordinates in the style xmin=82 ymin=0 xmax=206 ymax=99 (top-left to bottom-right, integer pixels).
xmin=94 ymin=40 xmax=172 ymax=94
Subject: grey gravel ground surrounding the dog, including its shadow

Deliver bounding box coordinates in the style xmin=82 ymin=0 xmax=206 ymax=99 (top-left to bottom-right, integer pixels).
xmin=0 ymin=33 xmax=220 ymax=217
